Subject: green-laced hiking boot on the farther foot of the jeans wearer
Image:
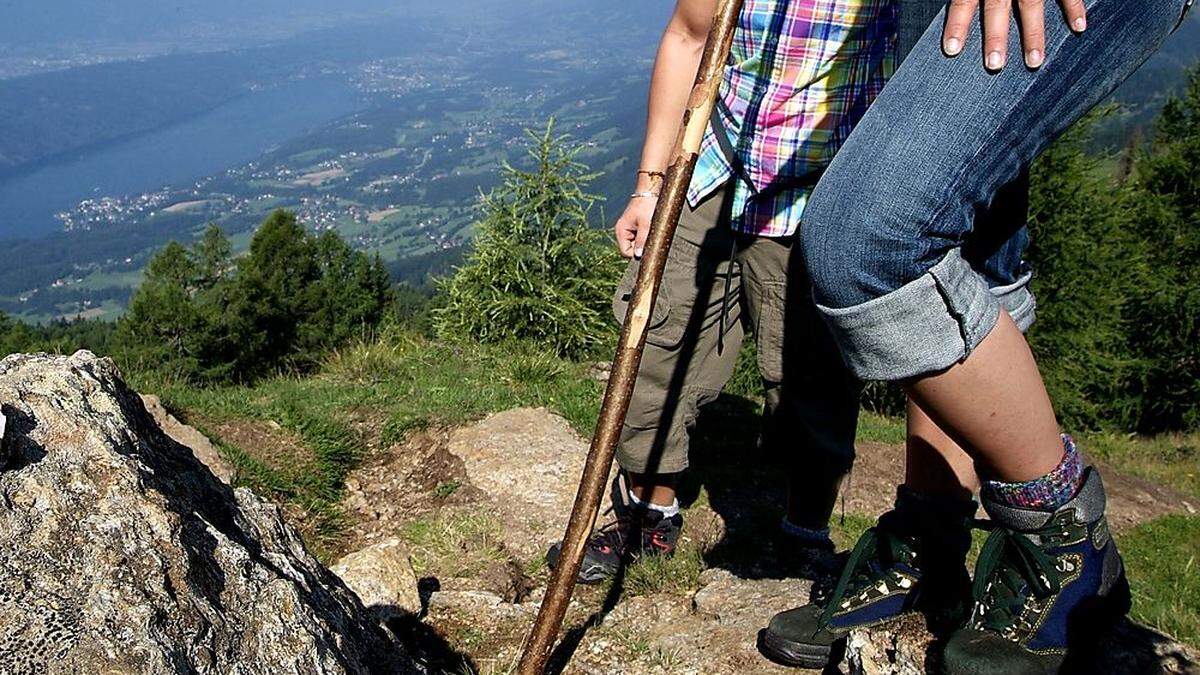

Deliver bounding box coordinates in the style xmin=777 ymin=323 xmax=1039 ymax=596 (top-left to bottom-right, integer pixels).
xmin=760 ymin=488 xmax=976 ymax=668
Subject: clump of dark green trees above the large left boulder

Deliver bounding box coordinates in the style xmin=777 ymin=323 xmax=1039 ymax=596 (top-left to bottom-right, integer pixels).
xmin=114 ymin=211 xmax=394 ymax=382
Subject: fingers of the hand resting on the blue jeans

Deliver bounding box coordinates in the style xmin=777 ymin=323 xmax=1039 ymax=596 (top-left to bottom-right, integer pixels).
xmin=942 ymin=0 xmax=1089 ymax=71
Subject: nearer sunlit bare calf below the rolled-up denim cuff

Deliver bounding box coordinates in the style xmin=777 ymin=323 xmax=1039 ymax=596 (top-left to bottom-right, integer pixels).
xmin=905 ymin=311 xmax=1063 ymax=483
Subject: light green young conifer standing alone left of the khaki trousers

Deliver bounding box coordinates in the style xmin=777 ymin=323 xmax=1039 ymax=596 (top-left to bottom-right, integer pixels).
xmin=434 ymin=120 xmax=620 ymax=357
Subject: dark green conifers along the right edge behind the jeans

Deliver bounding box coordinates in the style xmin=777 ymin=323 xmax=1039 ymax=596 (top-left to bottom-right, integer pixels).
xmin=1030 ymin=68 xmax=1200 ymax=431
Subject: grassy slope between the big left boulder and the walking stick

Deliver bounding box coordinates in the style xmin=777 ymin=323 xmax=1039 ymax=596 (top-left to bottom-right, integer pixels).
xmin=145 ymin=331 xmax=601 ymax=557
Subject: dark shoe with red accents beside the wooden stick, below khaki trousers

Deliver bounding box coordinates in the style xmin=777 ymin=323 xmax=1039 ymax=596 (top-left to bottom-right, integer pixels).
xmin=546 ymin=472 xmax=683 ymax=584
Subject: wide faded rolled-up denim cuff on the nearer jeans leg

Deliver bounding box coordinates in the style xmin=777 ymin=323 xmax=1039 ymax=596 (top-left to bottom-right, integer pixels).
xmin=817 ymin=249 xmax=1012 ymax=381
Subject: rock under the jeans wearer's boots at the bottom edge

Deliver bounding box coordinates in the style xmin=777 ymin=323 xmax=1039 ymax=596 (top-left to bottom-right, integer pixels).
xmin=846 ymin=616 xmax=1200 ymax=675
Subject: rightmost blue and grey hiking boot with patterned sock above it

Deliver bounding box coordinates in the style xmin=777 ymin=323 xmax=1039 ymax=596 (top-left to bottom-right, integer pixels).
xmin=943 ymin=467 xmax=1129 ymax=675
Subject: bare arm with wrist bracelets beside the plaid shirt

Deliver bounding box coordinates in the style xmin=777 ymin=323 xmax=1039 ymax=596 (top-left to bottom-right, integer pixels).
xmin=613 ymin=0 xmax=716 ymax=258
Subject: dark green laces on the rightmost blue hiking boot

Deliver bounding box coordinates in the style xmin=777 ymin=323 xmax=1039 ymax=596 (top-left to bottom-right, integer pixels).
xmin=971 ymin=521 xmax=1062 ymax=632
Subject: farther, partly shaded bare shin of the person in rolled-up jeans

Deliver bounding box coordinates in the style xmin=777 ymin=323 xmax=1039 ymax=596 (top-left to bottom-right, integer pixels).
xmin=904 ymin=399 xmax=979 ymax=500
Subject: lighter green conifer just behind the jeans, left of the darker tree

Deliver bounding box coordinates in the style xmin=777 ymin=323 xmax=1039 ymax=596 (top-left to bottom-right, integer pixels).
xmin=1028 ymin=110 xmax=1140 ymax=430
